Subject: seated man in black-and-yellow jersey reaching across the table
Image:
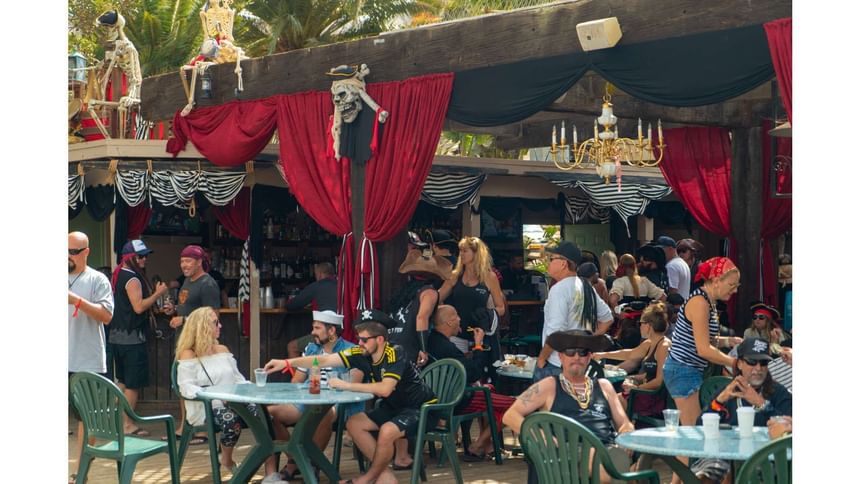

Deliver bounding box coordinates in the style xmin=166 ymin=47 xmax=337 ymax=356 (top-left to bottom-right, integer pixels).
xmin=265 ymin=309 xmax=436 ymax=484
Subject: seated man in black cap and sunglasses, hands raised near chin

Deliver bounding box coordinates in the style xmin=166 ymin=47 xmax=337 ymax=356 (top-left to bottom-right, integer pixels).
xmin=690 ymin=338 xmax=791 ymax=482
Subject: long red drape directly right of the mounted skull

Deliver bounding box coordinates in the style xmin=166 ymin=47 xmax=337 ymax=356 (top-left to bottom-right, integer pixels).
xmin=357 ymin=73 xmax=454 ymax=308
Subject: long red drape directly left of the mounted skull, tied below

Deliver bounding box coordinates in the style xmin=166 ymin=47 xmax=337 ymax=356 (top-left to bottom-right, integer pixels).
xmin=277 ymin=91 xmax=356 ymax=340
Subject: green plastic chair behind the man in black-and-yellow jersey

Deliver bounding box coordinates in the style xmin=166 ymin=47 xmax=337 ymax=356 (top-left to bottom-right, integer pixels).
xmin=412 ymin=358 xmax=466 ymax=484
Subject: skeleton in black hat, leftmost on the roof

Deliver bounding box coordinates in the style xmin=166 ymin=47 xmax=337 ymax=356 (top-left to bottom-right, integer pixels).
xmin=85 ymin=10 xmax=143 ymax=139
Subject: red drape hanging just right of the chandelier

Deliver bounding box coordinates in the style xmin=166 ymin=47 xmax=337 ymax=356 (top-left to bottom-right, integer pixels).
xmin=660 ymin=128 xmax=737 ymax=322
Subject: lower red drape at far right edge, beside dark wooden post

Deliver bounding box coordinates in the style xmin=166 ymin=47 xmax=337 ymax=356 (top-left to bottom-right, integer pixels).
xmin=759 ymin=121 xmax=792 ymax=305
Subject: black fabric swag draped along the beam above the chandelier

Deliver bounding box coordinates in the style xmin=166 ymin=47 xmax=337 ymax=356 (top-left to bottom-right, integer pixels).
xmin=447 ymin=24 xmax=774 ymax=126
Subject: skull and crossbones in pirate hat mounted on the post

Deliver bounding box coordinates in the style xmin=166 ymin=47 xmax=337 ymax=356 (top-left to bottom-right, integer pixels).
xmin=326 ymin=64 xmax=388 ymax=160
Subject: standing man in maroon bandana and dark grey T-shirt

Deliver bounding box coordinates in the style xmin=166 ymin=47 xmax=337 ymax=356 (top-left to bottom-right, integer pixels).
xmin=164 ymin=245 xmax=221 ymax=445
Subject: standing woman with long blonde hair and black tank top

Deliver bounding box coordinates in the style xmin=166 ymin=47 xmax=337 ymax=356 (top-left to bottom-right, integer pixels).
xmin=439 ymin=237 xmax=505 ymax=353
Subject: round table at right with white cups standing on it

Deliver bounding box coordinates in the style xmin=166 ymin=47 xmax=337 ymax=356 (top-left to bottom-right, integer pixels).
xmin=615 ymin=425 xmax=770 ymax=484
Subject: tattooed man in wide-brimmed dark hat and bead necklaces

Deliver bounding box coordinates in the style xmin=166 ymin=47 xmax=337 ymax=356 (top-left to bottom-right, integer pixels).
xmin=502 ymin=329 xmax=633 ymax=482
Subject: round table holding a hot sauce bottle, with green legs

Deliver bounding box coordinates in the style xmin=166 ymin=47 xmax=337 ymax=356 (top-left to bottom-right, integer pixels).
xmin=197 ymin=383 xmax=373 ymax=484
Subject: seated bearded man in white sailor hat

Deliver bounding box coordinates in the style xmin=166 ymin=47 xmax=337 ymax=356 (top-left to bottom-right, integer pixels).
xmin=268 ymin=311 xmax=364 ymax=481
